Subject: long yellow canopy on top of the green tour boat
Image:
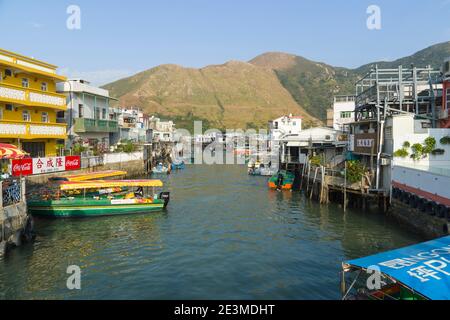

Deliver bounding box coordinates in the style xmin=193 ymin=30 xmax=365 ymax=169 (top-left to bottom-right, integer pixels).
xmin=60 ymin=179 xmax=163 ymax=190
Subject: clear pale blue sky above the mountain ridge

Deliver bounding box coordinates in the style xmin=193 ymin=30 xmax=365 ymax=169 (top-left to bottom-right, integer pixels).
xmin=0 ymin=0 xmax=450 ymax=85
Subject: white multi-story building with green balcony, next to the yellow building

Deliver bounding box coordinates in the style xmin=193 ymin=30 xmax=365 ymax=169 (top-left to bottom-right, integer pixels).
xmin=57 ymin=79 xmax=118 ymax=148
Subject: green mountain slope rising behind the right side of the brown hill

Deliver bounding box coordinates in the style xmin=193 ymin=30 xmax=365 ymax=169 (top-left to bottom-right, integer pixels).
xmin=250 ymin=52 xmax=358 ymax=120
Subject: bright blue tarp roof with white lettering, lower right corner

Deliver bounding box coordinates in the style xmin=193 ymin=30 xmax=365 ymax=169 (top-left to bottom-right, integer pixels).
xmin=346 ymin=236 xmax=450 ymax=300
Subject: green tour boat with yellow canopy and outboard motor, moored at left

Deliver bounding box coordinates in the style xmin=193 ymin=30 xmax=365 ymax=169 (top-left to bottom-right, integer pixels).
xmin=27 ymin=179 xmax=170 ymax=217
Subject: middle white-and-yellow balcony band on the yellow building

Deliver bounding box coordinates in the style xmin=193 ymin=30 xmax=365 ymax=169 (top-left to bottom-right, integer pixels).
xmin=0 ymin=83 xmax=67 ymax=110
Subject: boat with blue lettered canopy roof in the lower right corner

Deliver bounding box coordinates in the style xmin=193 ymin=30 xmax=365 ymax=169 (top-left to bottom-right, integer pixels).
xmin=341 ymin=236 xmax=450 ymax=300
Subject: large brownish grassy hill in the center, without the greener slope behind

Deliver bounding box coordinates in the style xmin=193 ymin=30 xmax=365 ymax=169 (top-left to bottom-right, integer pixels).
xmin=104 ymin=61 xmax=320 ymax=129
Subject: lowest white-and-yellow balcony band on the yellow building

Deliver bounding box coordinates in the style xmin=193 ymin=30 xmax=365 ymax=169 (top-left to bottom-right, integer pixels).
xmin=0 ymin=120 xmax=66 ymax=139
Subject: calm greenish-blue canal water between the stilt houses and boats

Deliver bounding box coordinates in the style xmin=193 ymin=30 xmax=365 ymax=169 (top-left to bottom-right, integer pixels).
xmin=0 ymin=165 xmax=423 ymax=299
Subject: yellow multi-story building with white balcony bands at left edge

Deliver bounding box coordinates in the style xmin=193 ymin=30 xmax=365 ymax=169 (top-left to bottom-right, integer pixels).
xmin=0 ymin=49 xmax=67 ymax=157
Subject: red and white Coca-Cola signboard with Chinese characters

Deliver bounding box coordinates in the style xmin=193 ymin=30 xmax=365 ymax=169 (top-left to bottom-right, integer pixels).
xmin=11 ymin=156 xmax=81 ymax=177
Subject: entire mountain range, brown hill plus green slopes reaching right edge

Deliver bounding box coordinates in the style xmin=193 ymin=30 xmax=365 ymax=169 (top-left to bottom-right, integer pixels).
xmin=104 ymin=42 xmax=450 ymax=129
